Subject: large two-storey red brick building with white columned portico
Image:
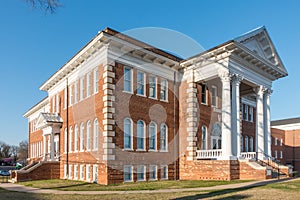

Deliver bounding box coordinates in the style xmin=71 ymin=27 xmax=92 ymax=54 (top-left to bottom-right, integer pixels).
xmin=24 ymin=27 xmax=287 ymax=184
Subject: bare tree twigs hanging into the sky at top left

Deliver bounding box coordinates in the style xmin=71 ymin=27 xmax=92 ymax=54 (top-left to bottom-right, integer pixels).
xmin=26 ymin=0 xmax=62 ymax=13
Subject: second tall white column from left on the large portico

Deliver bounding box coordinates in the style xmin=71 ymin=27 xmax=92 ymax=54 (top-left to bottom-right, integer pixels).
xmin=231 ymin=74 xmax=243 ymax=157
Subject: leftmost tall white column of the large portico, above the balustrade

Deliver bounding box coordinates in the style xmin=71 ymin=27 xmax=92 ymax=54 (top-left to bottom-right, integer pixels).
xmin=221 ymin=72 xmax=232 ymax=160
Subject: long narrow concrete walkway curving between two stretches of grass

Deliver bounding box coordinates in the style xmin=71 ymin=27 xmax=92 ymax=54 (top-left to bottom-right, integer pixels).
xmin=0 ymin=177 xmax=300 ymax=195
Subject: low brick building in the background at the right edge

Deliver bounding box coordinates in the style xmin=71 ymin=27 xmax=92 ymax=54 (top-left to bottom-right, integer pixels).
xmin=271 ymin=118 xmax=300 ymax=171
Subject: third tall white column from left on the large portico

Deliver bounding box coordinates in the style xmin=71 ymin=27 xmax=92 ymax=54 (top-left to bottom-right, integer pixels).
xmin=256 ymin=86 xmax=264 ymax=160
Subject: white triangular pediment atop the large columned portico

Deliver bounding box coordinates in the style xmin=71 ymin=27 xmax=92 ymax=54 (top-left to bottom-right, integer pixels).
xmin=234 ymin=27 xmax=287 ymax=73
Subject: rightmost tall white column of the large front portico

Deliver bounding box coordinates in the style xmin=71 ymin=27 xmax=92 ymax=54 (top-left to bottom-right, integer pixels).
xmin=264 ymin=89 xmax=272 ymax=156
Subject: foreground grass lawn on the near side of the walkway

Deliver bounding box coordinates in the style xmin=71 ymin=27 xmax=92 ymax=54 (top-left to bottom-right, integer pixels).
xmin=0 ymin=181 xmax=300 ymax=200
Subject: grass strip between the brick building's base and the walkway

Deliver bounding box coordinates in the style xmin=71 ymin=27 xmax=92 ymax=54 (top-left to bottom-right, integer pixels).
xmin=20 ymin=179 xmax=245 ymax=191
